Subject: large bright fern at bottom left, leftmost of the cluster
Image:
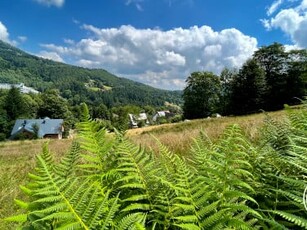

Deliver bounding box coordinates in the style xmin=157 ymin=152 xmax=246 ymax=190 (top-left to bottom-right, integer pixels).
xmin=7 ymin=141 xmax=118 ymax=229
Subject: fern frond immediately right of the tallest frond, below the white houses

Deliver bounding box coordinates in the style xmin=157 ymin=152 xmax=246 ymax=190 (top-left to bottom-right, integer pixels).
xmin=112 ymin=139 xmax=158 ymax=228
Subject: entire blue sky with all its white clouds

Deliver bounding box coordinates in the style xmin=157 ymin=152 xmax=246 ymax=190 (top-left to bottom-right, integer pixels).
xmin=0 ymin=0 xmax=307 ymax=89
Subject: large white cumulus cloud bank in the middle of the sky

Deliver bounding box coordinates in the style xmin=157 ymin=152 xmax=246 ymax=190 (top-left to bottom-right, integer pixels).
xmin=42 ymin=25 xmax=257 ymax=89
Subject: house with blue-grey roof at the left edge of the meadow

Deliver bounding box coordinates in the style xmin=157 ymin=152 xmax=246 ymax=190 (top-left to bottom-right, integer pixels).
xmin=10 ymin=118 xmax=64 ymax=139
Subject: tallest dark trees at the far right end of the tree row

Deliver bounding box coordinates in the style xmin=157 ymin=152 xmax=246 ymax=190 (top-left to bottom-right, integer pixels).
xmin=254 ymin=43 xmax=307 ymax=110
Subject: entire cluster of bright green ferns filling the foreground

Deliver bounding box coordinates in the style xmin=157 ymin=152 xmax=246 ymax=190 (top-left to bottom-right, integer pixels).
xmin=6 ymin=107 xmax=307 ymax=230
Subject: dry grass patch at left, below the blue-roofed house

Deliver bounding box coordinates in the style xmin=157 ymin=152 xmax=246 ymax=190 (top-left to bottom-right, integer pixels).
xmin=0 ymin=139 xmax=72 ymax=230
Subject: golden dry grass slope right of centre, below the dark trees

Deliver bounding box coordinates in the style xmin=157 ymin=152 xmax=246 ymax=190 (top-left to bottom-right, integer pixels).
xmin=127 ymin=111 xmax=286 ymax=154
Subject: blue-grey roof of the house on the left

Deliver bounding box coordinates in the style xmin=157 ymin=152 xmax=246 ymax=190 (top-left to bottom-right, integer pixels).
xmin=11 ymin=118 xmax=64 ymax=138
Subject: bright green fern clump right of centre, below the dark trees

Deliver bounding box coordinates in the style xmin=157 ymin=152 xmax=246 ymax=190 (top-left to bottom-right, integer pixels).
xmin=192 ymin=126 xmax=260 ymax=229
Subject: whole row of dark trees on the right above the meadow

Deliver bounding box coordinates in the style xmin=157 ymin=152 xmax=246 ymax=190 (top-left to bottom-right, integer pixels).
xmin=183 ymin=43 xmax=307 ymax=119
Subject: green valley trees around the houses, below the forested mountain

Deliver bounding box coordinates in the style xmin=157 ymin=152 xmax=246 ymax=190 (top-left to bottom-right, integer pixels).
xmin=0 ymin=87 xmax=181 ymax=141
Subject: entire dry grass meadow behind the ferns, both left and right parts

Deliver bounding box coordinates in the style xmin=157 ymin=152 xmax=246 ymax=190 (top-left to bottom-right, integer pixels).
xmin=0 ymin=111 xmax=285 ymax=229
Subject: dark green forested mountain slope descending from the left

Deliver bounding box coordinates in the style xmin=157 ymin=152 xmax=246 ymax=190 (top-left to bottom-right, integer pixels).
xmin=0 ymin=41 xmax=181 ymax=108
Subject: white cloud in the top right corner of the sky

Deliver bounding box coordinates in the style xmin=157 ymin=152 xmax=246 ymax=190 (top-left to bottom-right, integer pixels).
xmin=261 ymin=0 xmax=307 ymax=48
